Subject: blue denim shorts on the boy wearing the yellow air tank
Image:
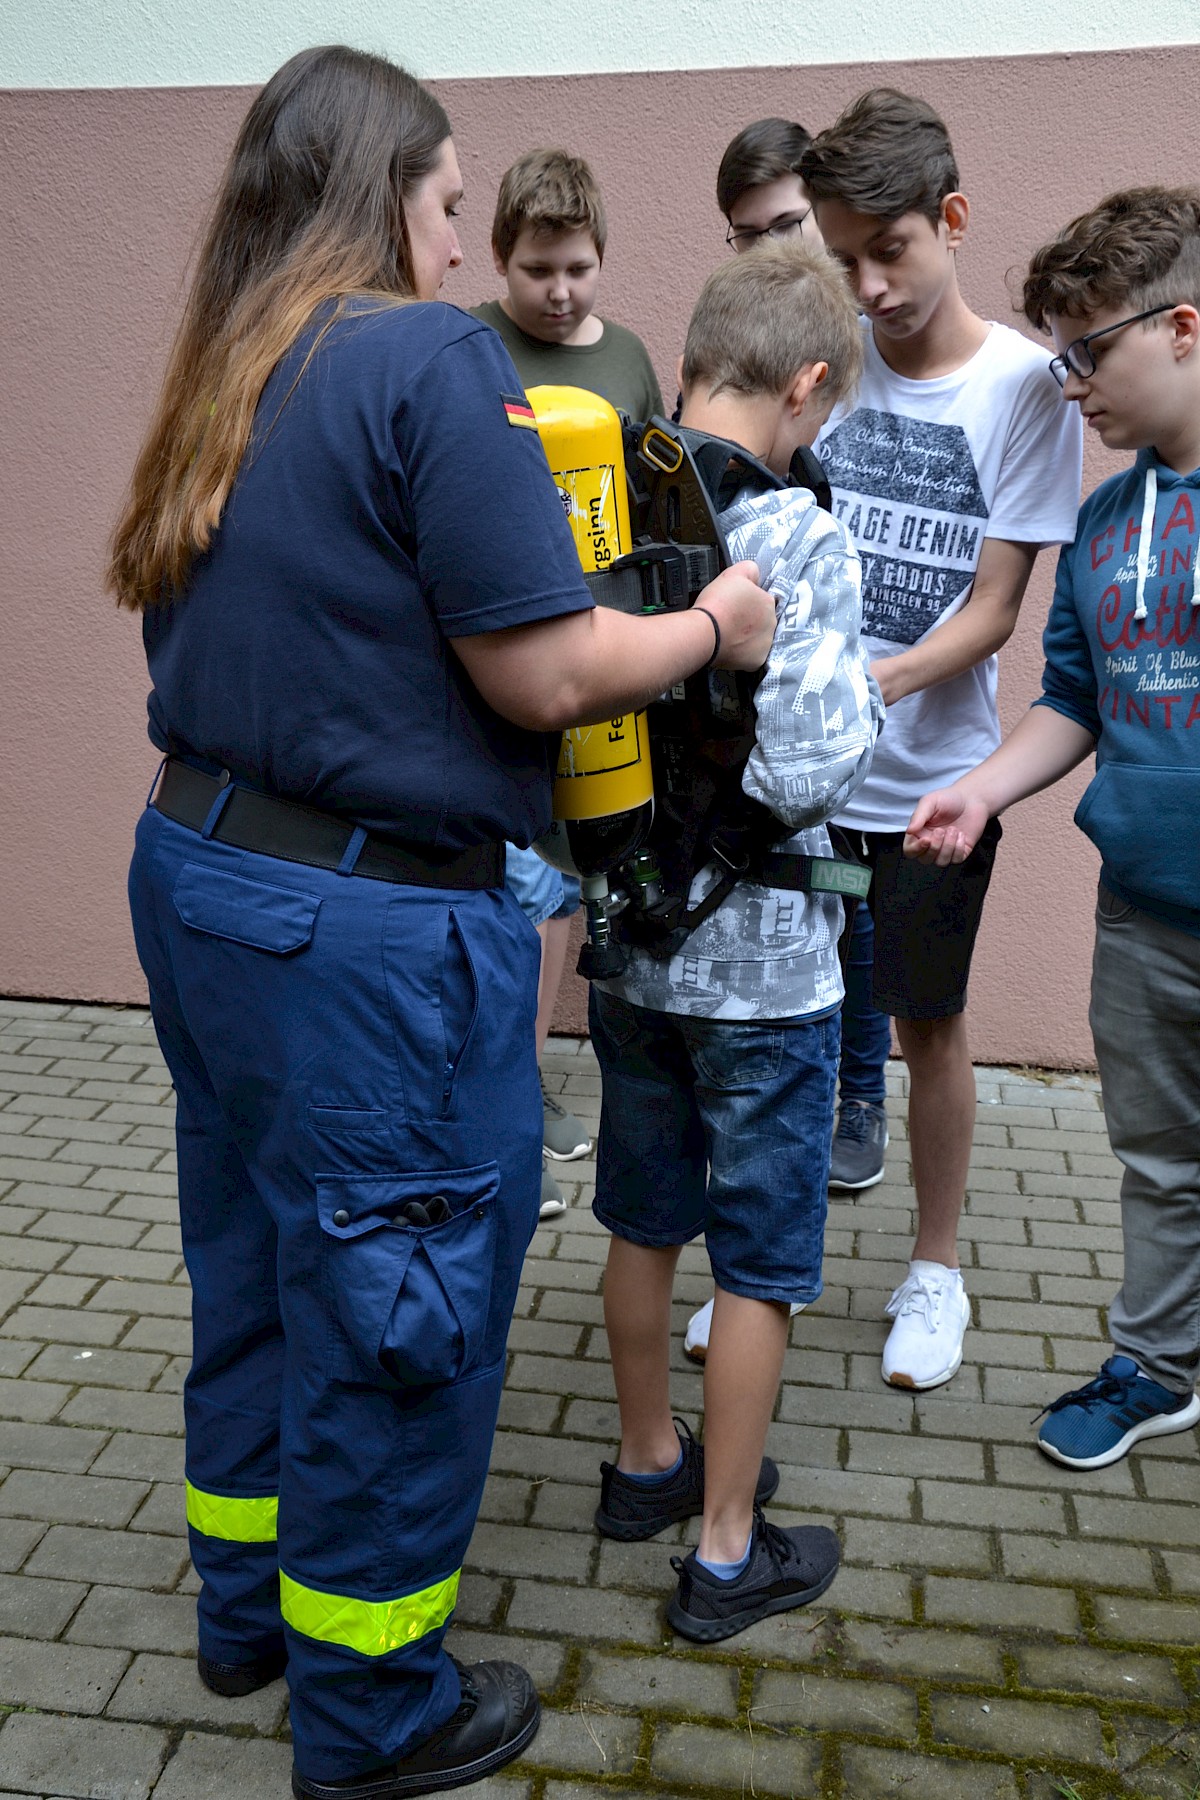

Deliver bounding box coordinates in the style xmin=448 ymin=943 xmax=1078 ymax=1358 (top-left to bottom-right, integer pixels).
xmin=590 ymin=988 xmax=840 ymax=1303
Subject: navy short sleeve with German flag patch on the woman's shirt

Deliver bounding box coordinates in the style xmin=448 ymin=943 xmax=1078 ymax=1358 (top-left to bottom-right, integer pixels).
xmin=392 ymin=328 xmax=594 ymax=637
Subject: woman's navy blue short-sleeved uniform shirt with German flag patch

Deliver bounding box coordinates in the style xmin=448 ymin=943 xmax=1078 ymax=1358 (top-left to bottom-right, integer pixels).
xmin=144 ymin=302 xmax=592 ymax=848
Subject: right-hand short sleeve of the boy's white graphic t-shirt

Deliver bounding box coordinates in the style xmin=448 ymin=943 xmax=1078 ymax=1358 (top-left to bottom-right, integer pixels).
xmin=984 ymin=364 xmax=1083 ymax=544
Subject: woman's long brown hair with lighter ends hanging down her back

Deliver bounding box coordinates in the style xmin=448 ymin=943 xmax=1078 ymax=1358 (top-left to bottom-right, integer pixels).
xmin=108 ymin=45 xmax=450 ymax=610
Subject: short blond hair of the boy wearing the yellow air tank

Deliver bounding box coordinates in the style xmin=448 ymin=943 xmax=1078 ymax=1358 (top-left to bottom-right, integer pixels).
xmin=684 ymin=243 xmax=862 ymax=405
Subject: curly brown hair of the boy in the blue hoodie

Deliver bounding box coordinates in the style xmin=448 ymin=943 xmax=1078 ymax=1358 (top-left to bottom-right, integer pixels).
xmin=1022 ymin=187 xmax=1200 ymax=331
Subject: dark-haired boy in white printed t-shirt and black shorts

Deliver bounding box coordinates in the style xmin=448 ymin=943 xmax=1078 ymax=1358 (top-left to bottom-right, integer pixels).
xmin=801 ymin=88 xmax=1083 ymax=1388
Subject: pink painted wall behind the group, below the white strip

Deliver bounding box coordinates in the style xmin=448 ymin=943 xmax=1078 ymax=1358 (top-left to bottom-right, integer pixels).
xmin=0 ymin=49 xmax=1200 ymax=1064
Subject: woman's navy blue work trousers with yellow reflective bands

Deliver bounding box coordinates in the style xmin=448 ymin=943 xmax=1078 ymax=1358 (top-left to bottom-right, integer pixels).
xmin=130 ymin=808 xmax=542 ymax=1780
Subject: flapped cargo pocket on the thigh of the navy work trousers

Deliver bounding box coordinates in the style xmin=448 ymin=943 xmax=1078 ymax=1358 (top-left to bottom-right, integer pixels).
xmin=317 ymin=1163 xmax=500 ymax=1386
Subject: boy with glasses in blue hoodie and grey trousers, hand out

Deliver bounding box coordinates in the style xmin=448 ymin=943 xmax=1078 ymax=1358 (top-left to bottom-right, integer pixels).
xmin=905 ymin=187 xmax=1200 ymax=1469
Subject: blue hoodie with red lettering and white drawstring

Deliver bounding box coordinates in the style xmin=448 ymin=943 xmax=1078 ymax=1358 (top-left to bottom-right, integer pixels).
xmin=1036 ymin=450 xmax=1200 ymax=936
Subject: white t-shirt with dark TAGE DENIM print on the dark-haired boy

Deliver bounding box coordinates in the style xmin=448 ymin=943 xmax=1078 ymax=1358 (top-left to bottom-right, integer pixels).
xmin=817 ymin=320 xmax=1083 ymax=832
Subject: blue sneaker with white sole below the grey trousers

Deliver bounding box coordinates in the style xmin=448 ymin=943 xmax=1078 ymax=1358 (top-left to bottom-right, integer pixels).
xmin=1038 ymin=1355 xmax=1200 ymax=1469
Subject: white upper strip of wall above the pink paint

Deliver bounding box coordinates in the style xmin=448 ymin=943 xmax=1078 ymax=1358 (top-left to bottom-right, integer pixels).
xmin=0 ymin=0 xmax=1200 ymax=88
